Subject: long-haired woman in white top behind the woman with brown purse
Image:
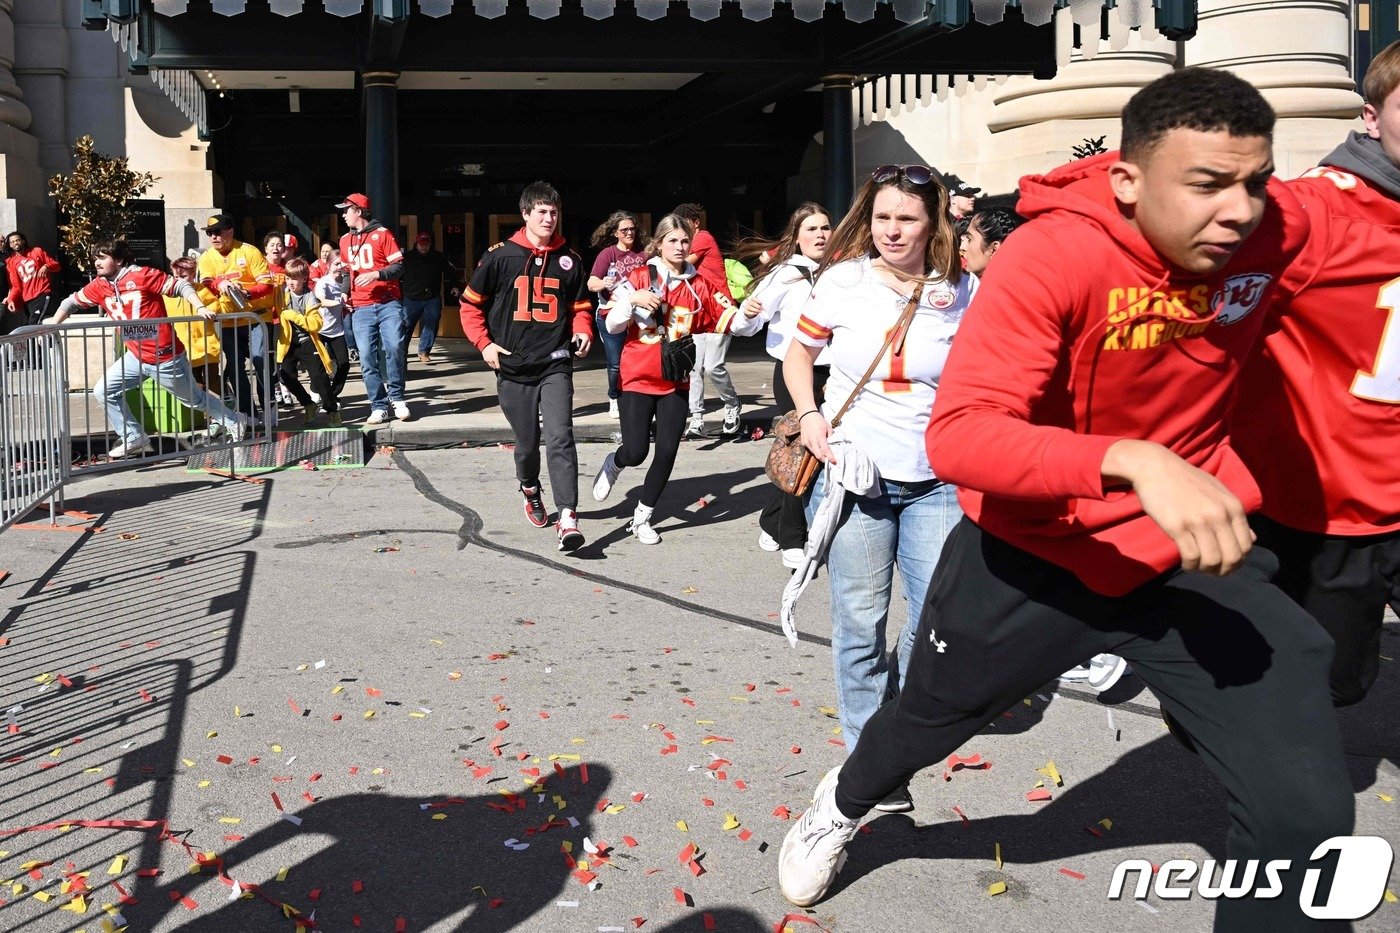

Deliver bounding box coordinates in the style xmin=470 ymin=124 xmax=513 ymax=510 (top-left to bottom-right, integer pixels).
xmin=734 ymin=200 xmax=832 ymax=569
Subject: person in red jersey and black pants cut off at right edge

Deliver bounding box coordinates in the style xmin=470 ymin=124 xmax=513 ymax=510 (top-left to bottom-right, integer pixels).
xmin=1231 ymin=43 xmax=1400 ymax=706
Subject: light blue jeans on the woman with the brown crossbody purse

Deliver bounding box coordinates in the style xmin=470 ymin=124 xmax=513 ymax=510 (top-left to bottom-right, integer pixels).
xmin=806 ymin=471 xmax=962 ymax=751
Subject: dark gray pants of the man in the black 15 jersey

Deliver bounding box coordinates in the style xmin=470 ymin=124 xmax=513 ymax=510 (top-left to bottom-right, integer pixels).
xmin=496 ymin=371 xmax=578 ymax=509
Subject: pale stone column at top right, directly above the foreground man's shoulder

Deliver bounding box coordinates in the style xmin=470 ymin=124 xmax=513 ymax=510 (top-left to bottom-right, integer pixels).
xmin=1184 ymin=0 xmax=1362 ymax=178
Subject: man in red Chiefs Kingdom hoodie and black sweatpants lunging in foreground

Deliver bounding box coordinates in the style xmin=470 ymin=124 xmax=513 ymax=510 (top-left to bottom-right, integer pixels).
xmin=778 ymin=69 xmax=1354 ymax=933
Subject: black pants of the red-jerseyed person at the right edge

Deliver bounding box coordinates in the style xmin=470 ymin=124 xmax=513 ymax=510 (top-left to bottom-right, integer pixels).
xmin=1249 ymin=514 xmax=1400 ymax=706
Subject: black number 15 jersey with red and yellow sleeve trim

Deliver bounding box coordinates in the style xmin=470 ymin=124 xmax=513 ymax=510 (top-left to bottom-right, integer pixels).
xmin=462 ymin=230 xmax=594 ymax=382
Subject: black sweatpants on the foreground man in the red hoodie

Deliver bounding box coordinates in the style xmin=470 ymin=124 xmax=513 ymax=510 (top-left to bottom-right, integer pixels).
xmin=836 ymin=518 xmax=1354 ymax=933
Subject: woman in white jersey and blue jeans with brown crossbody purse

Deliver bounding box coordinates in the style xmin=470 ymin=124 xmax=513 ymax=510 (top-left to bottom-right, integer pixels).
xmin=783 ymin=165 xmax=977 ymax=813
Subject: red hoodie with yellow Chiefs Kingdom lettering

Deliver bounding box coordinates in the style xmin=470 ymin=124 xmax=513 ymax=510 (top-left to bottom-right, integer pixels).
xmin=927 ymin=153 xmax=1308 ymax=595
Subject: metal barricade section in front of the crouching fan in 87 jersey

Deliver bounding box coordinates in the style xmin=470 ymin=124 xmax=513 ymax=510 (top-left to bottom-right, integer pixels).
xmin=53 ymin=311 xmax=277 ymax=476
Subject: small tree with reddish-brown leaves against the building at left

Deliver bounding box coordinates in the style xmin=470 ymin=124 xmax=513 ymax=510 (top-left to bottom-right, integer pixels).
xmin=49 ymin=136 xmax=160 ymax=275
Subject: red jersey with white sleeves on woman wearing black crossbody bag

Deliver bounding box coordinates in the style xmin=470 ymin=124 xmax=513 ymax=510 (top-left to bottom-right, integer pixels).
xmin=613 ymin=259 xmax=739 ymax=395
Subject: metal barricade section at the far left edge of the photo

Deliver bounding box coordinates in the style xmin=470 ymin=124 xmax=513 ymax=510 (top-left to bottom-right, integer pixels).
xmin=0 ymin=326 xmax=70 ymax=531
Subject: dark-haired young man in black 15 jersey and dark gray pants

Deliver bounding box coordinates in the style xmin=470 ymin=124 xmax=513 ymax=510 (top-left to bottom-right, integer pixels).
xmin=462 ymin=182 xmax=592 ymax=551
